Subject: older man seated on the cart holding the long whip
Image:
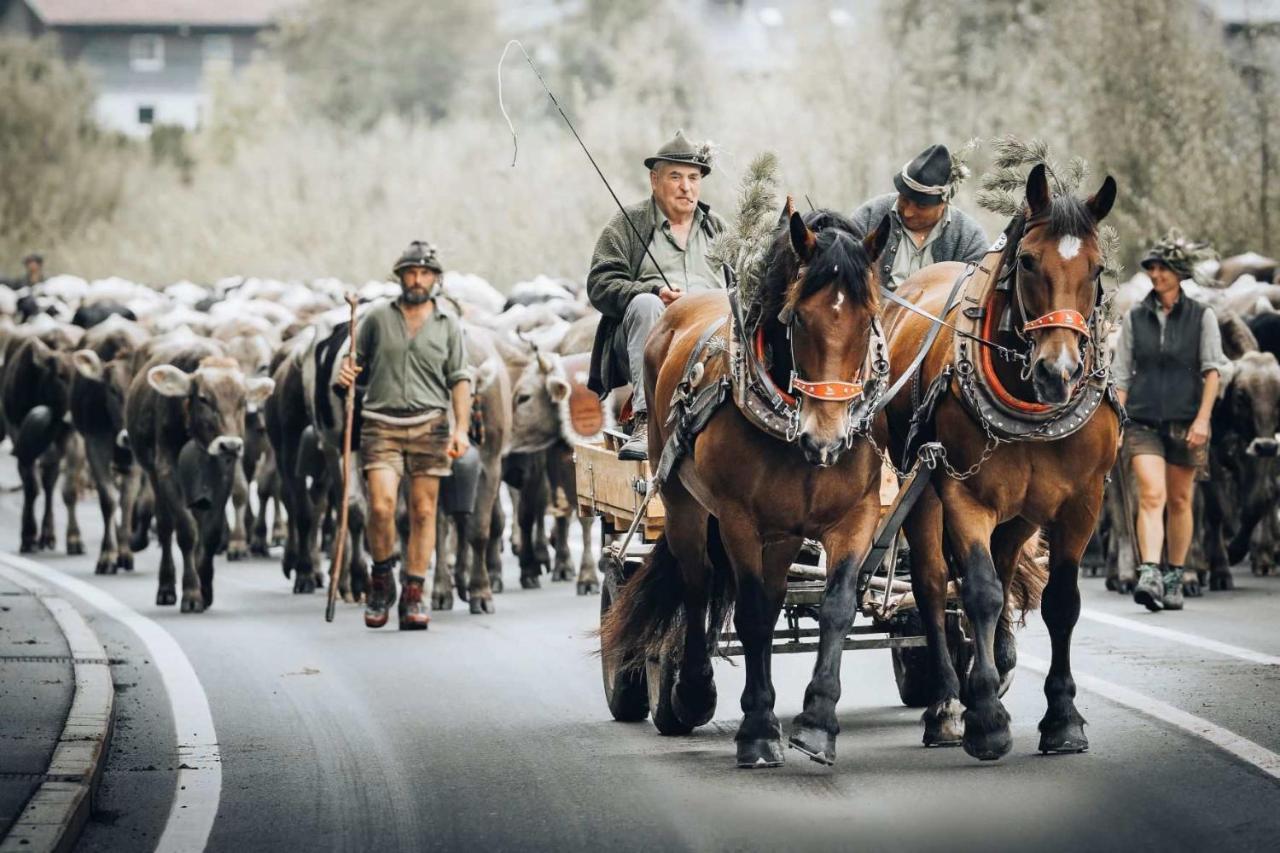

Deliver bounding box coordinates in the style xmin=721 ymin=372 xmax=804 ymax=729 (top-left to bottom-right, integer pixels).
xmin=586 ymin=131 xmax=726 ymax=460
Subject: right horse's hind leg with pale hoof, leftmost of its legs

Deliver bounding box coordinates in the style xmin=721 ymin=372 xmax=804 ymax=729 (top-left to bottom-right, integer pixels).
xmin=902 ymin=488 xmax=964 ymax=747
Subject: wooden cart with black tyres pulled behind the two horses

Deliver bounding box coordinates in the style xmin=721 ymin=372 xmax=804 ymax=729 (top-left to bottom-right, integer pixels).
xmin=575 ymin=432 xmax=972 ymax=717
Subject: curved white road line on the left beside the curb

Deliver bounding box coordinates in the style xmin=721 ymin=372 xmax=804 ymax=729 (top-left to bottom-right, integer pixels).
xmin=0 ymin=553 xmax=223 ymax=853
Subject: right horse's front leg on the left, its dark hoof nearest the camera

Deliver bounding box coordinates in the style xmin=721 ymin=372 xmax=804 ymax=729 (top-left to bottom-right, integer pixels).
xmin=942 ymin=480 xmax=1014 ymax=761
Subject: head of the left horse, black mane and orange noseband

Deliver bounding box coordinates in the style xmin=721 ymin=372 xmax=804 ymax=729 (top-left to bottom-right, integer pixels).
xmin=763 ymin=199 xmax=890 ymax=466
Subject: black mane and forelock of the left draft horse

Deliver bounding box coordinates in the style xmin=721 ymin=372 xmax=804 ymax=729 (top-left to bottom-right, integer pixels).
xmin=760 ymin=210 xmax=877 ymax=324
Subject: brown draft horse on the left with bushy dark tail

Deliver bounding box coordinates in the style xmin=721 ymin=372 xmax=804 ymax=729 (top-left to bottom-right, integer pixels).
xmin=602 ymin=201 xmax=888 ymax=767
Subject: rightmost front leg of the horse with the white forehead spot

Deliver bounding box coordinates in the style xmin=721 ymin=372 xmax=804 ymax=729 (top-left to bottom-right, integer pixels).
xmin=1039 ymin=496 xmax=1101 ymax=753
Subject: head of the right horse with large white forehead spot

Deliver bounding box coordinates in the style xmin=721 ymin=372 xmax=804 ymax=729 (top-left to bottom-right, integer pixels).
xmin=1014 ymin=164 xmax=1116 ymax=405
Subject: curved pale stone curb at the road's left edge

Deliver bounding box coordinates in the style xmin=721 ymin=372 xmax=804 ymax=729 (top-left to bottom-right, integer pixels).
xmin=0 ymin=565 xmax=115 ymax=853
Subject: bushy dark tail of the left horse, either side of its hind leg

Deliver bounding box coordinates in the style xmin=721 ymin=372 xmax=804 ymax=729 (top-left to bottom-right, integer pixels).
xmin=600 ymin=519 xmax=735 ymax=669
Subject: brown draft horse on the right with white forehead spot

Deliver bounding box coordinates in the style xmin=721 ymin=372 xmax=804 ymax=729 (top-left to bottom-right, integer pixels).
xmin=884 ymin=165 xmax=1120 ymax=761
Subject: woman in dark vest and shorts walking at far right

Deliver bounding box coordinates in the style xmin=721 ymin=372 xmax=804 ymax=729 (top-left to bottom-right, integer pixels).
xmin=1111 ymin=232 xmax=1226 ymax=611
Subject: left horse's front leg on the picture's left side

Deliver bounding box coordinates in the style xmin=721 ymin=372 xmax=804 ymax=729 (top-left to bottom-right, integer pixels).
xmin=721 ymin=514 xmax=794 ymax=768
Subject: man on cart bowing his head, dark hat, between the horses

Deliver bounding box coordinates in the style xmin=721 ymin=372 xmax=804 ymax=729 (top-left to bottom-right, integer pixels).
xmin=852 ymin=145 xmax=988 ymax=289
